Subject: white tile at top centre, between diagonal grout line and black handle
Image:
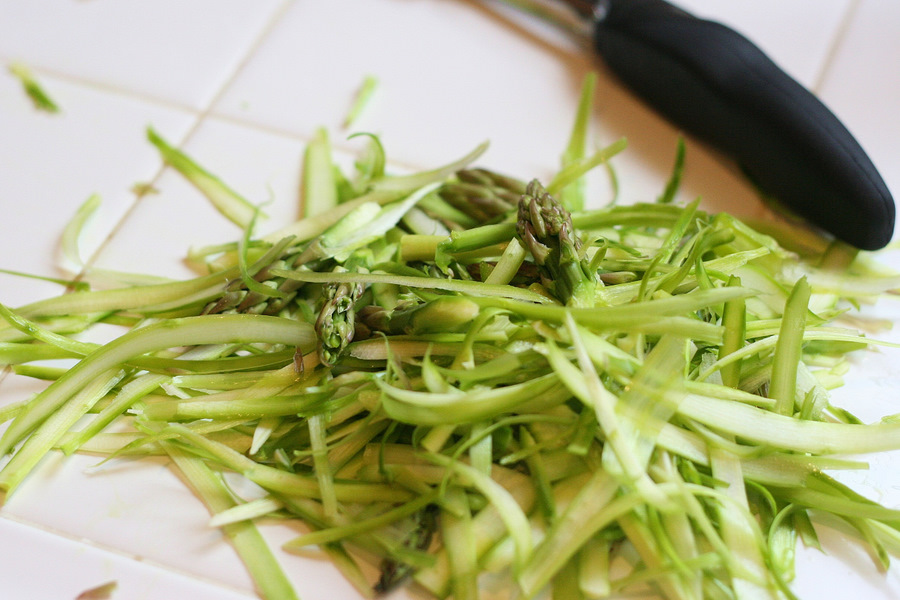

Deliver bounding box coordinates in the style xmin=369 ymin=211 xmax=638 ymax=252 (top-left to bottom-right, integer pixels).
xmin=214 ymin=0 xmax=590 ymax=178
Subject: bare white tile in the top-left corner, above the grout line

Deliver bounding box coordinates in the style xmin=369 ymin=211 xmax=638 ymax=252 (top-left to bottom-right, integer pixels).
xmin=0 ymin=0 xmax=282 ymax=109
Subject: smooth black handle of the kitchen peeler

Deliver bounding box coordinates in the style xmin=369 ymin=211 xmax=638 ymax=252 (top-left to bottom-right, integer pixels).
xmin=595 ymin=0 xmax=895 ymax=250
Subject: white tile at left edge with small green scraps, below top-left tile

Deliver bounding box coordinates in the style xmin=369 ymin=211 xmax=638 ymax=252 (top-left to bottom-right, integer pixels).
xmin=0 ymin=65 xmax=195 ymax=306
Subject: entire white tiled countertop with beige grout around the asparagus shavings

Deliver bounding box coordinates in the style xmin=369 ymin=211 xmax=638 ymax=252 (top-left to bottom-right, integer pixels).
xmin=0 ymin=0 xmax=900 ymax=600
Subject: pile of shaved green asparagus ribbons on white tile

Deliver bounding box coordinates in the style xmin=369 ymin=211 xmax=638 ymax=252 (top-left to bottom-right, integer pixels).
xmin=0 ymin=81 xmax=900 ymax=600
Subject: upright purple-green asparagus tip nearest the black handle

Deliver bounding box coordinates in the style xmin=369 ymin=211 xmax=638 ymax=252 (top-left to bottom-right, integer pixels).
xmin=516 ymin=180 xmax=597 ymax=307
